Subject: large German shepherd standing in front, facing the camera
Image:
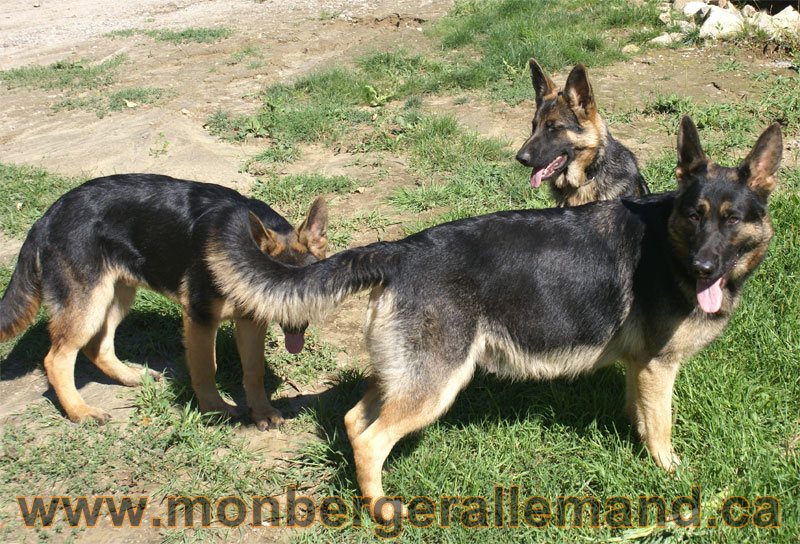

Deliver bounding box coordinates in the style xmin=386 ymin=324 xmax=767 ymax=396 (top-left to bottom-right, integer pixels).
xmin=207 ymin=117 xmax=782 ymax=517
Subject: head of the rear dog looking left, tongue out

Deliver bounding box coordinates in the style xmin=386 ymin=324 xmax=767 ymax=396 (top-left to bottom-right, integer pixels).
xmin=517 ymin=59 xmax=607 ymax=187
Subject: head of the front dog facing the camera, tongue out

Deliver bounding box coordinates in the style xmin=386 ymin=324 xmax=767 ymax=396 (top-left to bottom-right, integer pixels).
xmin=669 ymin=116 xmax=783 ymax=313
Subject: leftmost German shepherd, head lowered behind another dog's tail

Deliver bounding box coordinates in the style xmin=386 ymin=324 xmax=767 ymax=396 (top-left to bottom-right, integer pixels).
xmin=0 ymin=174 xmax=327 ymax=430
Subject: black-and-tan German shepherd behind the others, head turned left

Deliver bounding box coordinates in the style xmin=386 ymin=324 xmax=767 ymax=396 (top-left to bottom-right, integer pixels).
xmin=517 ymin=59 xmax=650 ymax=207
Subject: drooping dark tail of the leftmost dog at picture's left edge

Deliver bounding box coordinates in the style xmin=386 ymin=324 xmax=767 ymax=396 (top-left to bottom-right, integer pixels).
xmin=0 ymin=233 xmax=42 ymax=342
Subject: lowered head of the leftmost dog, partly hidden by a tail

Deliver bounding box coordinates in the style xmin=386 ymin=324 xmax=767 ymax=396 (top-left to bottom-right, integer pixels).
xmin=250 ymin=197 xmax=328 ymax=353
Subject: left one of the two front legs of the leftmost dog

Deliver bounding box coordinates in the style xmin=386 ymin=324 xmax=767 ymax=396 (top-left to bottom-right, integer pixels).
xmin=183 ymin=312 xmax=238 ymax=416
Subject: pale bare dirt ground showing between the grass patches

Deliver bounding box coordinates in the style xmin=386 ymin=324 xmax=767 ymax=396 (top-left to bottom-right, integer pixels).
xmin=0 ymin=0 xmax=796 ymax=542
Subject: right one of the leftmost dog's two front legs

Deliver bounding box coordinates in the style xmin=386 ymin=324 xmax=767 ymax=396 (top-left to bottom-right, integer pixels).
xmin=234 ymin=319 xmax=283 ymax=431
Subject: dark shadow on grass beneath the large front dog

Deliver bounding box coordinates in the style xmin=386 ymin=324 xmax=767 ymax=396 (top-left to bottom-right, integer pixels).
xmin=288 ymin=367 xmax=637 ymax=493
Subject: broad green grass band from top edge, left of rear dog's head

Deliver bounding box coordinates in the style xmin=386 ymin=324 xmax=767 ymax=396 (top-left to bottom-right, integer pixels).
xmin=207 ymin=0 xmax=658 ymax=172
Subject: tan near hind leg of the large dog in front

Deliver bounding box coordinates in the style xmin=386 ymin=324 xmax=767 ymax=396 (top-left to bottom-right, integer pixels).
xmin=352 ymin=359 xmax=475 ymax=520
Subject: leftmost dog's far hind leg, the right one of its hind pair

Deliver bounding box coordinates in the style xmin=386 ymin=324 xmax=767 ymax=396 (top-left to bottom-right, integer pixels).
xmin=83 ymin=283 xmax=161 ymax=386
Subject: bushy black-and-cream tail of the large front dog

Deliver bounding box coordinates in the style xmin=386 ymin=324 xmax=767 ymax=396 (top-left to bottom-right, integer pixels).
xmin=206 ymin=215 xmax=410 ymax=327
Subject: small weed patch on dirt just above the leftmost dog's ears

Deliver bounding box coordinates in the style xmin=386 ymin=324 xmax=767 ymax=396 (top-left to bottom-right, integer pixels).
xmin=250 ymin=174 xmax=359 ymax=220
